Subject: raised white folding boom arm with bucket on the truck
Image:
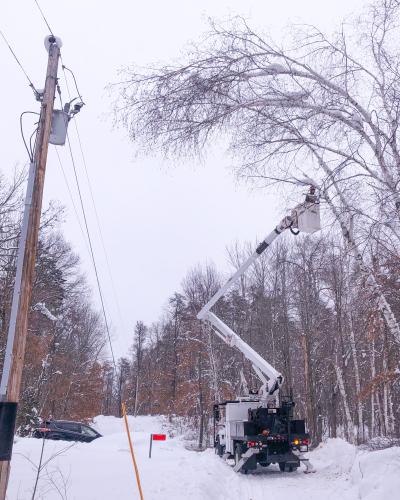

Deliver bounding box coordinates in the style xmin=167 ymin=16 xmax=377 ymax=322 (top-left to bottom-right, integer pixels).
xmin=197 ymin=187 xmax=321 ymax=402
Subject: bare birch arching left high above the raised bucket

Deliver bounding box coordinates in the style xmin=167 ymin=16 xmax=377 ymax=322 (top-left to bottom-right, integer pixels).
xmin=111 ymin=0 xmax=400 ymax=345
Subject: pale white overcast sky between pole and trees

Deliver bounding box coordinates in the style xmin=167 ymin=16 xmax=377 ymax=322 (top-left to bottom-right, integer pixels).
xmin=0 ymin=0 xmax=366 ymax=355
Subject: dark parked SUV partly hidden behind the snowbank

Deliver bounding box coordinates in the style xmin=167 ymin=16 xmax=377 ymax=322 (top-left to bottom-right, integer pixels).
xmin=32 ymin=420 xmax=101 ymax=443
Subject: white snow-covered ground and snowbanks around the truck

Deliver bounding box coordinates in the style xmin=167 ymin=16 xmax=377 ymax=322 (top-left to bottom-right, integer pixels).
xmin=7 ymin=417 xmax=400 ymax=500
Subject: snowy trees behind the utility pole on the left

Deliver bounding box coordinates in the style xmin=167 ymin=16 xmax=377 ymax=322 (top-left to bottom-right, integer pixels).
xmin=0 ymin=173 xmax=105 ymax=434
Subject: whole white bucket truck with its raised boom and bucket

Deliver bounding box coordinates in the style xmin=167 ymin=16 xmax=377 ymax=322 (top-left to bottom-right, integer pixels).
xmin=197 ymin=187 xmax=321 ymax=474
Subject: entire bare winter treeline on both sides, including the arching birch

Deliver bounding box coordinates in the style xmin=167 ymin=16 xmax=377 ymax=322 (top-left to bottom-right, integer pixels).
xmin=0 ymin=0 xmax=400 ymax=444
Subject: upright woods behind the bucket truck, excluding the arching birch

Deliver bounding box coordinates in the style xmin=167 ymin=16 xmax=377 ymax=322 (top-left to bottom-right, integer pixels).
xmin=118 ymin=232 xmax=400 ymax=443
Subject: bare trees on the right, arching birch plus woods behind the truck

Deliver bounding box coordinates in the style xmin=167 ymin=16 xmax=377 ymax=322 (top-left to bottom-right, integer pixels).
xmin=110 ymin=0 xmax=400 ymax=443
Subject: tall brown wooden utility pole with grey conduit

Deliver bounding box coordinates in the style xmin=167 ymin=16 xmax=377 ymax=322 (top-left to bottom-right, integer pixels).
xmin=0 ymin=36 xmax=61 ymax=500
